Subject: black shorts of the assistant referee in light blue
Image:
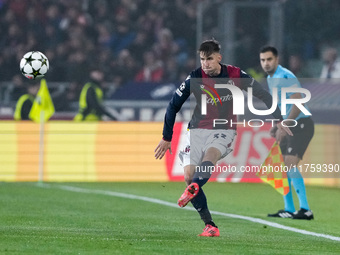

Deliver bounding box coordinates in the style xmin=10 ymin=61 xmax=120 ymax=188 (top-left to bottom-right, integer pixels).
xmin=280 ymin=117 xmax=314 ymax=159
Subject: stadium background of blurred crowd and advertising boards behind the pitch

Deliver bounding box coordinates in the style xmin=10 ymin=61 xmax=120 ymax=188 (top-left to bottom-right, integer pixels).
xmin=0 ymin=0 xmax=340 ymax=186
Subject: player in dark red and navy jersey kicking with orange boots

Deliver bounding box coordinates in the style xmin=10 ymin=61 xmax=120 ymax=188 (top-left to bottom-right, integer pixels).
xmin=155 ymin=40 xmax=291 ymax=237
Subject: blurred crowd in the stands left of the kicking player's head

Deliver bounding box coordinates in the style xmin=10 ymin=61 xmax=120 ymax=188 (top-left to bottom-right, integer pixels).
xmin=0 ymin=0 xmax=197 ymax=104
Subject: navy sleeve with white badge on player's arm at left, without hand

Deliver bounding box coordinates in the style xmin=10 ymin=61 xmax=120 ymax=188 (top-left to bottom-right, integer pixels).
xmin=163 ymin=75 xmax=191 ymax=141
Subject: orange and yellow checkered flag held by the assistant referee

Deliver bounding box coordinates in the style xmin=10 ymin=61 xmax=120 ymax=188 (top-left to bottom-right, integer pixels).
xmin=256 ymin=142 xmax=289 ymax=195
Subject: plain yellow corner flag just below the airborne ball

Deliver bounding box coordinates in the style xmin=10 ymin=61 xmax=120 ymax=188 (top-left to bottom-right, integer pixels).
xmin=29 ymin=79 xmax=55 ymax=122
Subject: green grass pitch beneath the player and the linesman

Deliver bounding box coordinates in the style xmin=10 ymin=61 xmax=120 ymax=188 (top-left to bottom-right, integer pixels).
xmin=0 ymin=182 xmax=340 ymax=255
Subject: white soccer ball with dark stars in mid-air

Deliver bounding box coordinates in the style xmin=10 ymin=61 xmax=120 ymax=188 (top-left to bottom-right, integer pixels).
xmin=20 ymin=51 xmax=50 ymax=80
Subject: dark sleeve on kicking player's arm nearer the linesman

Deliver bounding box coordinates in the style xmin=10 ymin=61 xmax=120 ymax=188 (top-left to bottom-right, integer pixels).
xmin=240 ymin=71 xmax=283 ymax=120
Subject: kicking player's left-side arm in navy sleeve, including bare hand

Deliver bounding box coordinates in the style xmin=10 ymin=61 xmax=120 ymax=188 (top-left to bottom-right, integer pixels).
xmin=155 ymin=77 xmax=190 ymax=159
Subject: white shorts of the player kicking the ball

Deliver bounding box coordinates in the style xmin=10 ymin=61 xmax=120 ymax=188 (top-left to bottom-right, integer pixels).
xmin=179 ymin=128 xmax=236 ymax=166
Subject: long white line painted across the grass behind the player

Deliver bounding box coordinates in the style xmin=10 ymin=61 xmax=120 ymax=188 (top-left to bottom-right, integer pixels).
xmin=37 ymin=183 xmax=340 ymax=242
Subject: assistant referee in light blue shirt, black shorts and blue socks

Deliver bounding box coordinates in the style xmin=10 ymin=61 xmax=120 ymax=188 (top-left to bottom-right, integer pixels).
xmin=260 ymin=46 xmax=314 ymax=220
